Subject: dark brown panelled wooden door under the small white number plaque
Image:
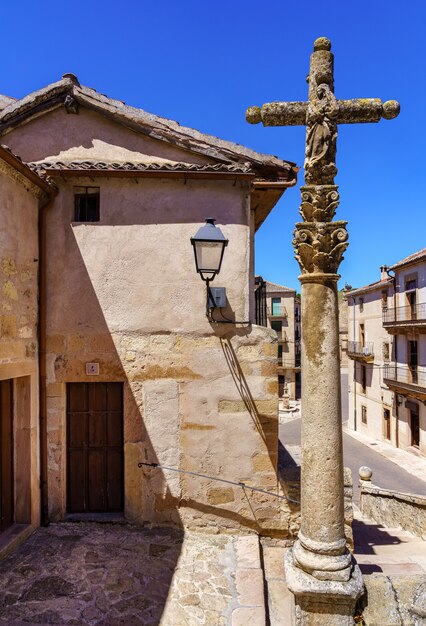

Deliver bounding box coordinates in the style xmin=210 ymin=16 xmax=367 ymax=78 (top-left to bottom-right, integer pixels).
xmin=67 ymin=383 xmax=124 ymax=513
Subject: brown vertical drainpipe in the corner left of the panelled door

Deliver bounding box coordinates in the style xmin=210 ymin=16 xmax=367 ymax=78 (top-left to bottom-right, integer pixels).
xmin=38 ymin=198 xmax=53 ymax=526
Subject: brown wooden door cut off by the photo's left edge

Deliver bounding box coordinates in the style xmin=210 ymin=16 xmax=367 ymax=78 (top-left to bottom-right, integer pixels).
xmin=0 ymin=380 xmax=15 ymax=531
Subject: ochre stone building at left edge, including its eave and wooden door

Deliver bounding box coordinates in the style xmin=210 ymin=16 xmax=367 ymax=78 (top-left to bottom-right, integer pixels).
xmin=0 ymin=145 xmax=56 ymax=548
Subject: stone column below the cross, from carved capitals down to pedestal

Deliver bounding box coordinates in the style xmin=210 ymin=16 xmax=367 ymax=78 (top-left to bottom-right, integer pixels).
xmin=286 ymin=185 xmax=363 ymax=626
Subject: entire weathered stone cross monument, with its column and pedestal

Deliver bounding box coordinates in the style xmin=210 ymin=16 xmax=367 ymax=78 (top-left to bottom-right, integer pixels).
xmin=246 ymin=37 xmax=399 ymax=626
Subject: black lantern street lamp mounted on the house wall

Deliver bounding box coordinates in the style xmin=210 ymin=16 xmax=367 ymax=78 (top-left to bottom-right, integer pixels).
xmin=191 ymin=217 xmax=228 ymax=320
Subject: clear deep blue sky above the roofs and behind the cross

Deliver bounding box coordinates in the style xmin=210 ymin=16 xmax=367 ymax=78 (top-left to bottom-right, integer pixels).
xmin=0 ymin=0 xmax=426 ymax=288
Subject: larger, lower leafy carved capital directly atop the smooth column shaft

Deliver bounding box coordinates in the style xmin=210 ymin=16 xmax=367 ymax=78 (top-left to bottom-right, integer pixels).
xmin=293 ymin=221 xmax=348 ymax=274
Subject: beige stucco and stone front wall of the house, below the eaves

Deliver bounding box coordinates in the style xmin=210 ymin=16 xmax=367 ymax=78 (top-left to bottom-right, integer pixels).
xmin=43 ymin=179 xmax=296 ymax=536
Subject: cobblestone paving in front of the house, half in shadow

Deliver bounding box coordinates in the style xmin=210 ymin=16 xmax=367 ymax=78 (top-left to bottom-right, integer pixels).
xmin=0 ymin=523 xmax=265 ymax=626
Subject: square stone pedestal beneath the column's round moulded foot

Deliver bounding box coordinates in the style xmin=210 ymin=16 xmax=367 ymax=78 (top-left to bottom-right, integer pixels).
xmin=284 ymin=549 xmax=364 ymax=626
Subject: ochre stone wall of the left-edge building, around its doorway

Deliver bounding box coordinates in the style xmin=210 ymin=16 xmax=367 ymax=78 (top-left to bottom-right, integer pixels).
xmin=0 ymin=162 xmax=40 ymax=525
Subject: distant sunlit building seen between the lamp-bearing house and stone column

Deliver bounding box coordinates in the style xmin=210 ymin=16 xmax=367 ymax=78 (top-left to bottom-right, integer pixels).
xmin=266 ymin=281 xmax=301 ymax=400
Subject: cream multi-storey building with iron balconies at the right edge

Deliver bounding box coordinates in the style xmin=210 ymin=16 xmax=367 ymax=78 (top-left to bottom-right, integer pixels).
xmin=347 ymin=249 xmax=426 ymax=454
